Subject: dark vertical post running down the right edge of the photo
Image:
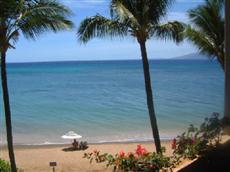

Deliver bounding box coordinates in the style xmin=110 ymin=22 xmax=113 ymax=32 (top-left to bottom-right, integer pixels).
xmin=224 ymin=0 xmax=230 ymax=124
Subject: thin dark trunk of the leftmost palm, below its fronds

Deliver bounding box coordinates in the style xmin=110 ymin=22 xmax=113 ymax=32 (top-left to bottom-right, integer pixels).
xmin=1 ymin=51 xmax=17 ymax=172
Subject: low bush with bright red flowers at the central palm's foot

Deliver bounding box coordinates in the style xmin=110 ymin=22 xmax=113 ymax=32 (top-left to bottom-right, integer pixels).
xmin=84 ymin=145 xmax=171 ymax=172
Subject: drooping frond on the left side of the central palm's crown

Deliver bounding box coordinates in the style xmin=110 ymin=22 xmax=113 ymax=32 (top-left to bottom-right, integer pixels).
xmin=77 ymin=15 xmax=128 ymax=43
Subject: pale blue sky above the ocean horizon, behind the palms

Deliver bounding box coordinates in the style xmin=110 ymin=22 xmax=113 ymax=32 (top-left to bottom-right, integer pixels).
xmin=7 ymin=0 xmax=204 ymax=62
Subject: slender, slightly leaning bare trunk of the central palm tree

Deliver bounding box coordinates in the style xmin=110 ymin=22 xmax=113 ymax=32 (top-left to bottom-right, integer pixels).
xmin=139 ymin=41 xmax=161 ymax=153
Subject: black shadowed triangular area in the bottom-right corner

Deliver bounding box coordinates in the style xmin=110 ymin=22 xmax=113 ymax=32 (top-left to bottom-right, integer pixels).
xmin=178 ymin=140 xmax=230 ymax=172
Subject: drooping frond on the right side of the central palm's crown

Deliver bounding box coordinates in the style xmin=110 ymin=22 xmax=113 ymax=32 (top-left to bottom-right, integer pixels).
xmin=150 ymin=21 xmax=185 ymax=43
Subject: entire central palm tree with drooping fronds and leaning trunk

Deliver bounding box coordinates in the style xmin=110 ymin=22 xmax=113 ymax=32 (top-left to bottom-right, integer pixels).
xmin=78 ymin=0 xmax=184 ymax=153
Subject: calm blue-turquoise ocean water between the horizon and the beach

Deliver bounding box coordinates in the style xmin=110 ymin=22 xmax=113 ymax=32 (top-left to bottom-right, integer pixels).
xmin=0 ymin=60 xmax=224 ymax=144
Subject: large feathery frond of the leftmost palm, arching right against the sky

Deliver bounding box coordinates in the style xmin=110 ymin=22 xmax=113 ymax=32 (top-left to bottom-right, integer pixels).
xmin=16 ymin=0 xmax=73 ymax=38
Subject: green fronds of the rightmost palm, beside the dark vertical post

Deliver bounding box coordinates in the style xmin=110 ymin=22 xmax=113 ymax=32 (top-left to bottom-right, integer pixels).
xmin=186 ymin=0 xmax=224 ymax=70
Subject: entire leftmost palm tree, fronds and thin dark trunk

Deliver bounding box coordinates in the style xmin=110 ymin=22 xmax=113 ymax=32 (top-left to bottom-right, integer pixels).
xmin=0 ymin=0 xmax=72 ymax=172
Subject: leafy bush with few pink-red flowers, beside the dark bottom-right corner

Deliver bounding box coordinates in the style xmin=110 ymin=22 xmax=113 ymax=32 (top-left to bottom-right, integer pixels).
xmin=171 ymin=113 xmax=222 ymax=159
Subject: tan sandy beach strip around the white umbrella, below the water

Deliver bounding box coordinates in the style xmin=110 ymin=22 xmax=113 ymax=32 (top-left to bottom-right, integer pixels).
xmin=1 ymin=142 xmax=172 ymax=172
